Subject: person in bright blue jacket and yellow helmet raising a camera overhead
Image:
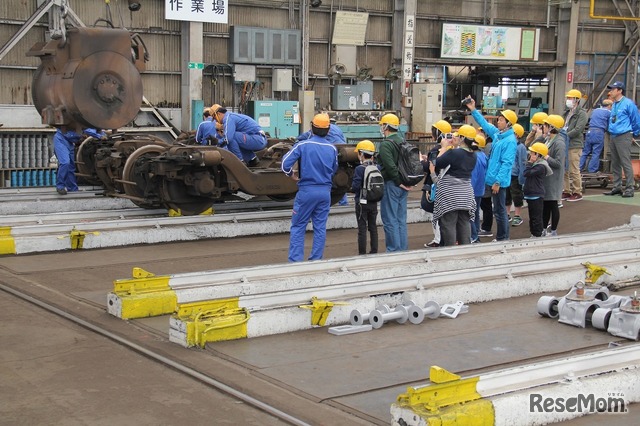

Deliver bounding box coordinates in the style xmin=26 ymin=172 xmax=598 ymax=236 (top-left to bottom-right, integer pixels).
xmin=464 ymin=96 xmax=518 ymax=241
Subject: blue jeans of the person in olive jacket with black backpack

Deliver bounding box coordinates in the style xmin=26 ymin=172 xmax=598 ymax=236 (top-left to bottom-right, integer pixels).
xmin=380 ymin=180 xmax=409 ymax=252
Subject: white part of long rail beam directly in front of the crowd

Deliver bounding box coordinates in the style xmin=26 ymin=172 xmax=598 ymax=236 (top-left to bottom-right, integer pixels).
xmin=142 ymin=227 xmax=640 ymax=294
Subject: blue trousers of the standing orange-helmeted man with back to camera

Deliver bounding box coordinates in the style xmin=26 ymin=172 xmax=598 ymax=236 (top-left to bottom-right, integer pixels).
xmin=289 ymin=185 xmax=331 ymax=262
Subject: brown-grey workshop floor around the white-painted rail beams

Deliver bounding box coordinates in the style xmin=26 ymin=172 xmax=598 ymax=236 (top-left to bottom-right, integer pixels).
xmin=0 ymin=190 xmax=640 ymax=425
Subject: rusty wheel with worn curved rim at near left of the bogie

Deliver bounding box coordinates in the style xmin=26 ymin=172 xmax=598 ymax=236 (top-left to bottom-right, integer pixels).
xmin=122 ymin=145 xmax=167 ymax=209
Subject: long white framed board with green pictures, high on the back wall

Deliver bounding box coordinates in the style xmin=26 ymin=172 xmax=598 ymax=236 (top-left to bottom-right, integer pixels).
xmin=440 ymin=24 xmax=540 ymax=61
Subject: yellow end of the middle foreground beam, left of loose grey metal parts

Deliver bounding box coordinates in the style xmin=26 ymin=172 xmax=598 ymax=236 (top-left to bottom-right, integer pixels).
xmin=174 ymin=298 xmax=250 ymax=348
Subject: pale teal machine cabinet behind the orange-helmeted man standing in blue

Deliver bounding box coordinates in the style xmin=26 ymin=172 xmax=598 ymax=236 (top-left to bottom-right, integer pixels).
xmin=249 ymin=101 xmax=300 ymax=139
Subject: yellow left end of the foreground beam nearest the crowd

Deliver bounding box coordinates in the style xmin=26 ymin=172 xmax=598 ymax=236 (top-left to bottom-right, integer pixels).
xmin=113 ymin=267 xmax=178 ymax=319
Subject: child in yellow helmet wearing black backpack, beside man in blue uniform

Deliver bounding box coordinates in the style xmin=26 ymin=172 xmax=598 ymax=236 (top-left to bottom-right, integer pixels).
xmin=351 ymin=140 xmax=384 ymax=254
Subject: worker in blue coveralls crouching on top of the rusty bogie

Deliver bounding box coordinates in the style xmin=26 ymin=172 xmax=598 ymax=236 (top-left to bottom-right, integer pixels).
xmin=211 ymin=104 xmax=267 ymax=166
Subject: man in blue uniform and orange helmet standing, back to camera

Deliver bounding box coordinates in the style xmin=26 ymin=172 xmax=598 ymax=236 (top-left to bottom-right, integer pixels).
xmin=282 ymin=114 xmax=338 ymax=262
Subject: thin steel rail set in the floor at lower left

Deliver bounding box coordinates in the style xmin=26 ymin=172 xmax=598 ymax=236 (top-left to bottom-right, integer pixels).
xmin=0 ymin=283 xmax=310 ymax=426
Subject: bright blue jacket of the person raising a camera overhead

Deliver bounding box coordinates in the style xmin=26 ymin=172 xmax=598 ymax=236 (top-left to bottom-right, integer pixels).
xmin=471 ymin=110 xmax=518 ymax=188
